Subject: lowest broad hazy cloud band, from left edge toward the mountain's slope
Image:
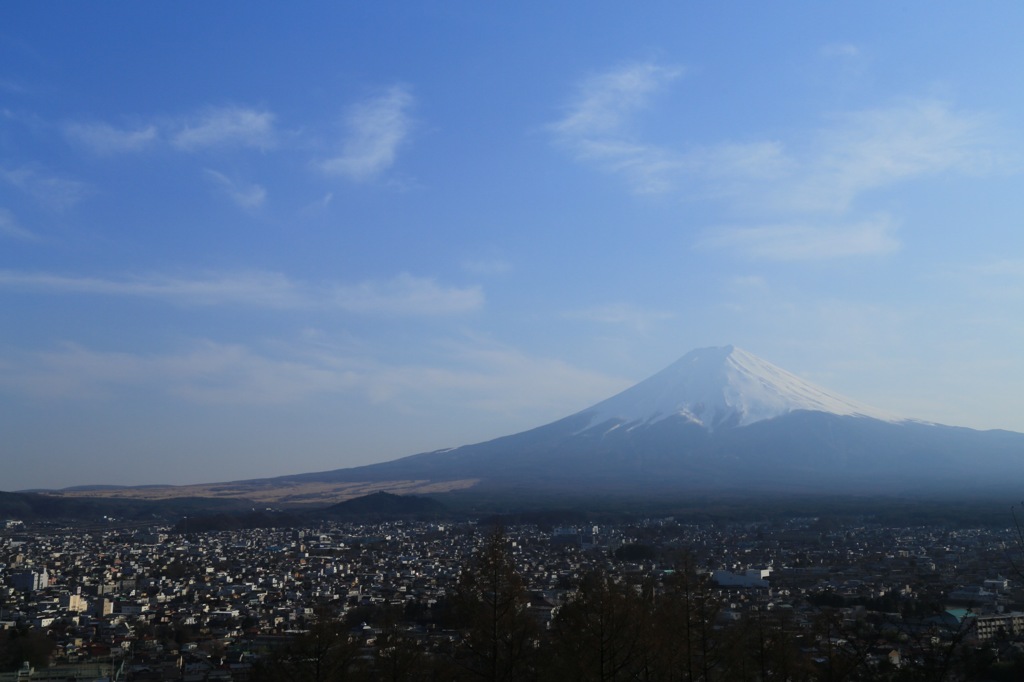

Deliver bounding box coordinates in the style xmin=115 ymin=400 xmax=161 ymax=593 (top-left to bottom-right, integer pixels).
xmin=0 ymin=333 xmax=629 ymax=418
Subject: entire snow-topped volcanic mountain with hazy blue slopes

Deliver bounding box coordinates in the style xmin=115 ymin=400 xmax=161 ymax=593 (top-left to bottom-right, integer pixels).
xmin=276 ymin=346 xmax=1024 ymax=494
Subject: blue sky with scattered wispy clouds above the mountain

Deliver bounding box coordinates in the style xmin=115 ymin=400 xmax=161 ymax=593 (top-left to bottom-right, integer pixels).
xmin=0 ymin=2 xmax=1024 ymax=489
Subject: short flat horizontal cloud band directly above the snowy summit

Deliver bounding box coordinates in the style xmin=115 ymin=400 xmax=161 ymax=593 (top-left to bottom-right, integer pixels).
xmin=697 ymin=217 xmax=900 ymax=261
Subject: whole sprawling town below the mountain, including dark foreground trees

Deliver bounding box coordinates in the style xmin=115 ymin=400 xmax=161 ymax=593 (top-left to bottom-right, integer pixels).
xmin=6 ymin=501 xmax=1024 ymax=682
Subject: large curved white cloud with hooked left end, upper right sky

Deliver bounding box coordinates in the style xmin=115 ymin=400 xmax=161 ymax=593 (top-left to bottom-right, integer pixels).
xmin=549 ymin=69 xmax=994 ymax=208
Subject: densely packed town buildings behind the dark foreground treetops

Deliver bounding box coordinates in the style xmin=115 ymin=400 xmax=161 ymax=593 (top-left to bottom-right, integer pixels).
xmin=0 ymin=518 xmax=1024 ymax=681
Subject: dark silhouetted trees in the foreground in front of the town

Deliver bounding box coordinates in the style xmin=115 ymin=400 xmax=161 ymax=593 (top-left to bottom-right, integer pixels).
xmin=252 ymin=531 xmax=1024 ymax=682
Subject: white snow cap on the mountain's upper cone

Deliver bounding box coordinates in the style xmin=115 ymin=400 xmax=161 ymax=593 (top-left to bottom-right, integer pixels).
xmin=579 ymin=346 xmax=903 ymax=429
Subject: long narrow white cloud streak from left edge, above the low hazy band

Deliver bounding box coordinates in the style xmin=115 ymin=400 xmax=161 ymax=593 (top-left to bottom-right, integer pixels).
xmin=0 ymin=270 xmax=484 ymax=315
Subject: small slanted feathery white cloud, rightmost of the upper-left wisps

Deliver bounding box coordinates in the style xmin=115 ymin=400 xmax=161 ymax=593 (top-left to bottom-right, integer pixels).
xmin=321 ymin=85 xmax=415 ymax=180
